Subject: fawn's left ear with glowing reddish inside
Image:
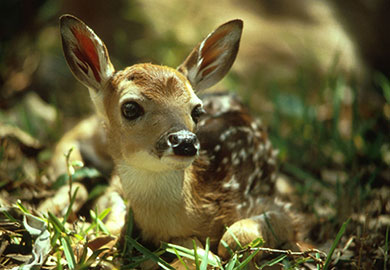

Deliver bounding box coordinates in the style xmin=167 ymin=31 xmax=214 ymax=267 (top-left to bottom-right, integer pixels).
xmin=60 ymin=15 xmax=114 ymax=91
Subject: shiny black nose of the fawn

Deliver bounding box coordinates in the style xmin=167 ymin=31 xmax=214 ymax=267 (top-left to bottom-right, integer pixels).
xmin=168 ymin=130 xmax=199 ymax=157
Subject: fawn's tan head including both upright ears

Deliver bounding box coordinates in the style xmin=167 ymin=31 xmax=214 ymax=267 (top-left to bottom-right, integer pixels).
xmin=60 ymin=15 xmax=243 ymax=172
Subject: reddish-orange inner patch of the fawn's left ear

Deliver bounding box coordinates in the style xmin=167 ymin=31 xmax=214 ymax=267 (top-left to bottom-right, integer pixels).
xmin=71 ymin=27 xmax=101 ymax=82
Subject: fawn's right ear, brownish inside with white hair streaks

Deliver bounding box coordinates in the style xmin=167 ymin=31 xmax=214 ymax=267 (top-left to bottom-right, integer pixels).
xmin=178 ymin=20 xmax=243 ymax=91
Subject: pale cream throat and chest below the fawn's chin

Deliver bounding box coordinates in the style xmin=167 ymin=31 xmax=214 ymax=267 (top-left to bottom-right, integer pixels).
xmin=117 ymin=160 xmax=197 ymax=245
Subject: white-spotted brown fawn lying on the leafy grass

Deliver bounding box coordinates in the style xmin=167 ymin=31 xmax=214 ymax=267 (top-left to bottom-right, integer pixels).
xmin=60 ymin=15 xmax=296 ymax=258
